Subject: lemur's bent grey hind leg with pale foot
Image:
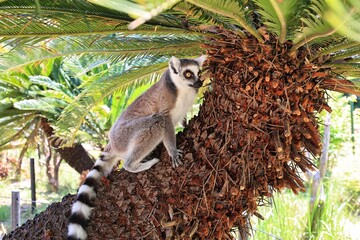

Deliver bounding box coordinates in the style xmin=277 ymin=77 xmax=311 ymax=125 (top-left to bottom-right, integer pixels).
xmin=123 ymin=113 xmax=165 ymax=173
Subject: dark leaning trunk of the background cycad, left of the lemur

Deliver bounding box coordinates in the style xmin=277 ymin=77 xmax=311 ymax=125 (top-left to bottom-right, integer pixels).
xmin=41 ymin=118 xmax=94 ymax=174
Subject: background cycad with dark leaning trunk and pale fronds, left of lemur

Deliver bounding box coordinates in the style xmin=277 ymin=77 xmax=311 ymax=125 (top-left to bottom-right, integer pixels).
xmin=0 ymin=59 xmax=98 ymax=174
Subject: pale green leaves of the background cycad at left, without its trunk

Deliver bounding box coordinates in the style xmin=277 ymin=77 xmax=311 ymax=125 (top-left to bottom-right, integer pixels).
xmin=0 ymin=59 xmax=110 ymax=152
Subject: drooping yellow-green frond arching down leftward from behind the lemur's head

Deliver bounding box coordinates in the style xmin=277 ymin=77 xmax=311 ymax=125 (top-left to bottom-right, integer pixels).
xmin=56 ymin=62 xmax=168 ymax=145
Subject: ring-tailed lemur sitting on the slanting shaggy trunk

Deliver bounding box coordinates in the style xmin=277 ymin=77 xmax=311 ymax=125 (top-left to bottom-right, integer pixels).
xmin=68 ymin=55 xmax=206 ymax=240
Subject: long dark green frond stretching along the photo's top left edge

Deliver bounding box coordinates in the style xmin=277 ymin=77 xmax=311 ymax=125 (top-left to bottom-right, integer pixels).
xmin=0 ymin=0 xmax=196 ymax=43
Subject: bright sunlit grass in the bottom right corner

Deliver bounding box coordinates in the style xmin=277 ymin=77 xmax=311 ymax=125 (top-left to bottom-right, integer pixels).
xmin=251 ymin=144 xmax=360 ymax=240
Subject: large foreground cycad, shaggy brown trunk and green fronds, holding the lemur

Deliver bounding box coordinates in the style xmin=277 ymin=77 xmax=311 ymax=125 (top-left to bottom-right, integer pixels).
xmin=0 ymin=0 xmax=360 ymax=239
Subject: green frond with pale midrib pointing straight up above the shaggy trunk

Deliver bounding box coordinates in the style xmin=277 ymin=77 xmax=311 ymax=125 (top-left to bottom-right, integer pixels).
xmin=255 ymin=0 xmax=302 ymax=43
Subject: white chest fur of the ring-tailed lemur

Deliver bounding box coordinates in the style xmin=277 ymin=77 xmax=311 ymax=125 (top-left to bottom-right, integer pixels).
xmin=170 ymin=88 xmax=196 ymax=125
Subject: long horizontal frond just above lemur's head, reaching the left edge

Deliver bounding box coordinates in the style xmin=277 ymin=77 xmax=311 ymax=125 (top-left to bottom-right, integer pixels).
xmin=0 ymin=34 xmax=200 ymax=71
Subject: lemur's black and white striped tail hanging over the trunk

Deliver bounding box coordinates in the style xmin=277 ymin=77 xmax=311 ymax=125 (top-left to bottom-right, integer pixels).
xmin=67 ymin=153 xmax=113 ymax=240
